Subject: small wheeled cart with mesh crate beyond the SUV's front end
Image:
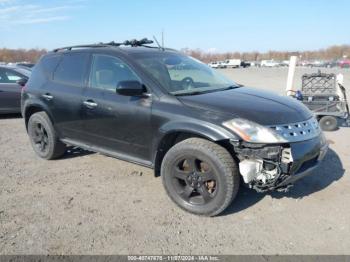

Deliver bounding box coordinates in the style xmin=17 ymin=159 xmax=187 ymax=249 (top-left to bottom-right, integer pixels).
xmin=295 ymin=71 xmax=349 ymax=131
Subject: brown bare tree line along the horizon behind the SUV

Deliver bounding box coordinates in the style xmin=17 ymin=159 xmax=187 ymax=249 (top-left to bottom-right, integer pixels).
xmin=0 ymin=45 xmax=350 ymax=63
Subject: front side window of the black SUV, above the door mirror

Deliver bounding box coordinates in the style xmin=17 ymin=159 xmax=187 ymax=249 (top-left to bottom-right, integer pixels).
xmin=90 ymin=55 xmax=140 ymax=92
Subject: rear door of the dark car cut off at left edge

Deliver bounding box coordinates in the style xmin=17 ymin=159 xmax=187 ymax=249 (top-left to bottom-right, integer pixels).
xmin=0 ymin=68 xmax=25 ymax=112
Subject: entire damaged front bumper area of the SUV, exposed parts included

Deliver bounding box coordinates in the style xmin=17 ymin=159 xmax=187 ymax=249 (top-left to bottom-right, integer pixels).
xmin=231 ymin=133 xmax=328 ymax=192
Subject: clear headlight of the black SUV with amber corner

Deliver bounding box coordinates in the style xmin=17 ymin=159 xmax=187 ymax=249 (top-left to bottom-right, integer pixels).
xmin=222 ymin=118 xmax=287 ymax=143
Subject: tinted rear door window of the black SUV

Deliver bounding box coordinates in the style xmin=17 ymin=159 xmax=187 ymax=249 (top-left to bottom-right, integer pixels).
xmin=53 ymin=53 xmax=89 ymax=86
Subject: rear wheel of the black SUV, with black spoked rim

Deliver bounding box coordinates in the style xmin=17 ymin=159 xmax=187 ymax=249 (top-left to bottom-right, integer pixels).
xmin=28 ymin=112 xmax=66 ymax=160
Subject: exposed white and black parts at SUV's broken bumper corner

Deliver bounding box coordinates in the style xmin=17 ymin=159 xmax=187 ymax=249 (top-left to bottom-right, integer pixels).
xmin=233 ymin=143 xmax=293 ymax=192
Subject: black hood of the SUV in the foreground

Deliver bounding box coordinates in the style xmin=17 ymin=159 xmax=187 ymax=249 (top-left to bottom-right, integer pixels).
xmin=178 ymin=87 xmax=312 ymax=125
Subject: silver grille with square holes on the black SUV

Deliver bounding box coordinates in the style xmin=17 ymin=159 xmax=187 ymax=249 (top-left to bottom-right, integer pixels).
xmin=270 ymin=117 xmax=321 ymax=142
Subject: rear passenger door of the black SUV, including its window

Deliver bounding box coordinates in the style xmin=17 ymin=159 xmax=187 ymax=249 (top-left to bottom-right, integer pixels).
xmin=41 ymin=51 xmax=90 ymax=140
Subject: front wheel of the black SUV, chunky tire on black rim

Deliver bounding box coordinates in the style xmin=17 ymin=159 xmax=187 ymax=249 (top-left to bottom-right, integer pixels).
xmin=161 ymin=138 xmax=240 ymax=216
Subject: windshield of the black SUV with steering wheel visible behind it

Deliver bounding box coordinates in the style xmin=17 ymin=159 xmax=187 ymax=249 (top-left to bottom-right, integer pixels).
xmin=136 ymin=52 xmax=238 ymax=95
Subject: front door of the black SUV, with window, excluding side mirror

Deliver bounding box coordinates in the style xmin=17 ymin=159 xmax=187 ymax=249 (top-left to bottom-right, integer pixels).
xmin=82 ymin=54 xmax=152 ymax=161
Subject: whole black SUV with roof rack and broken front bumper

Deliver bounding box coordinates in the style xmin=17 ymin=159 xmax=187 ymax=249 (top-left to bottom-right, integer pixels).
xmin=22 ymin=38 xmax=327 ymax=216
